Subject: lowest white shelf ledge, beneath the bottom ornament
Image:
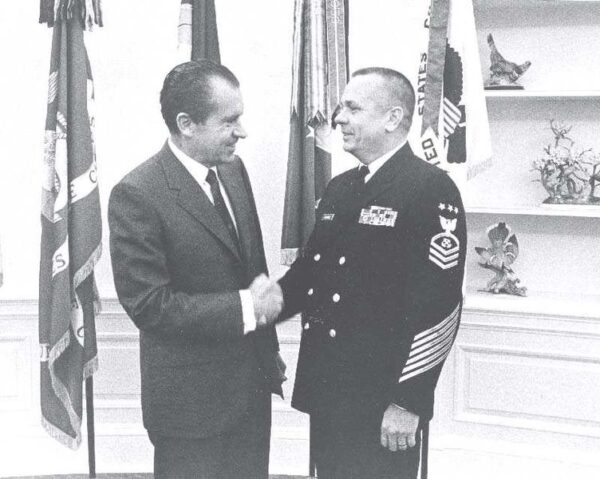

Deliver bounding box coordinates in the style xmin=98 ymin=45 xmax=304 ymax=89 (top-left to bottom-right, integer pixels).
xmin=465 ymin=289 xmax=600 ymax=320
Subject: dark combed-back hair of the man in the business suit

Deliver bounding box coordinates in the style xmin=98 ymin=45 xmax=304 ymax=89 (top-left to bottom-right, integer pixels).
xmin=160 ymin=60 xmax=240 ymax=134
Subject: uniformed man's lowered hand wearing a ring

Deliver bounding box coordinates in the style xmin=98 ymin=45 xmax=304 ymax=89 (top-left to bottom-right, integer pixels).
xmin=381 ymin=404 xmax=419 ymax=452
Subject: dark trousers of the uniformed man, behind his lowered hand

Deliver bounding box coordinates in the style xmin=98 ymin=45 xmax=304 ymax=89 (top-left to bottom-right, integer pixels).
xmin=311 ymin=411 xmax=420 ymax=479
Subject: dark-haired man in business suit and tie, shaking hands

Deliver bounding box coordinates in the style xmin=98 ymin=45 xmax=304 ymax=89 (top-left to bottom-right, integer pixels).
xmin=108 ymin=61 xmax=283 ymax=479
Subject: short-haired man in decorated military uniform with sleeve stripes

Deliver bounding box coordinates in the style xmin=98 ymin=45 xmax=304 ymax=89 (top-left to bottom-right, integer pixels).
xmin=280 ymin=68 xmax=466 ymax=479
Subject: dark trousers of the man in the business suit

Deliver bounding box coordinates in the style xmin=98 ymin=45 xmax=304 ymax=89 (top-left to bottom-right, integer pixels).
xmin=150 ymin=391 xmax=271 ymax=479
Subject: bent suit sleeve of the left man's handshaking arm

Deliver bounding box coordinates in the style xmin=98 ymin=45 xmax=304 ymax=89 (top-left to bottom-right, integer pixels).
xmin=108 ymin=182 xmax=244 ymax=338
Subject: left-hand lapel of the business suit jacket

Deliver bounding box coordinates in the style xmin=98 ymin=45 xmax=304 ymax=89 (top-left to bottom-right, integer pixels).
xmin=161 ymin=144 xmax=241 ymax=259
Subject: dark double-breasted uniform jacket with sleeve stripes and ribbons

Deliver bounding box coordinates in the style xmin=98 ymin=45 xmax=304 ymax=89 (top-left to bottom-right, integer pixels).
xmin=280 ymin=144 xmax=466 ymax=421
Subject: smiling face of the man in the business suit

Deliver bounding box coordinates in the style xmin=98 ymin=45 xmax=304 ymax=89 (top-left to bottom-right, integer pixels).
xmin=182 ymin=78 xmax=246 ymax=168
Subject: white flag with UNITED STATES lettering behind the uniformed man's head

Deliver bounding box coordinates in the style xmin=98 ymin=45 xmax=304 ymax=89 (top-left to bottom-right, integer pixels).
xmin=409 ymin=0 xmax=492 ymax=192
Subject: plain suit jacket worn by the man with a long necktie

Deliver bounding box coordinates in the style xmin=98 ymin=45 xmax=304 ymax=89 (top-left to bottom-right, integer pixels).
xmin=108 ymin=144 xmax=281 ymax=437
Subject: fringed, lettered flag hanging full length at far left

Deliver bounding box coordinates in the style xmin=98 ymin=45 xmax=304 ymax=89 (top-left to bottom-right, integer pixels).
xmin=39 ymin=0 xmax=102 ymax=449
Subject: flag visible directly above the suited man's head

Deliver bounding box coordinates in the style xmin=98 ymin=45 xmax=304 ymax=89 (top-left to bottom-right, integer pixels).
xmin=177 ymin=0 xmax=221 ymax=63
